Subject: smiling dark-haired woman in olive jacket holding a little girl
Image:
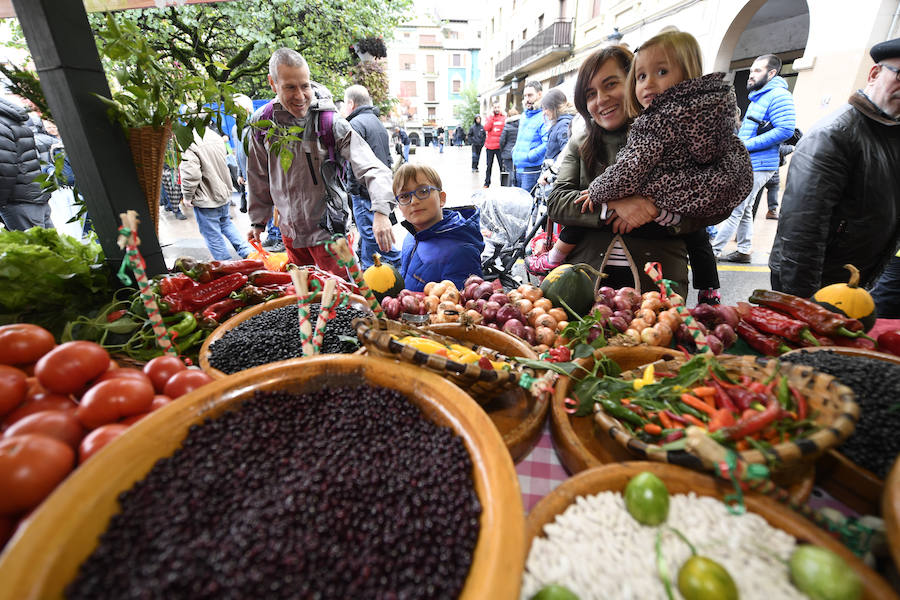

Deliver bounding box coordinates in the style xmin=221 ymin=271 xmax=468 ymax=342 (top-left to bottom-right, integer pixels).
xmin=536 ymin=46 xmax=699 ymax=295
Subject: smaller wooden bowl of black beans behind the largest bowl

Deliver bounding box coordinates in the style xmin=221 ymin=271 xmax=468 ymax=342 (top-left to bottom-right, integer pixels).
xmin=199 ymin=293 xmax=372 ymax=379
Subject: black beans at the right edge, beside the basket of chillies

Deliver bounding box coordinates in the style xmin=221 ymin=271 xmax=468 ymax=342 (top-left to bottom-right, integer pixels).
xmin=781 ymin=350 xmax=900 ymax=479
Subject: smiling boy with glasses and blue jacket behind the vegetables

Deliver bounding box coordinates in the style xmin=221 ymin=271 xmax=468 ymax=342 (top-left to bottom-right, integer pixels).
xmin=394 ymin=163 xmax=484 ymax=292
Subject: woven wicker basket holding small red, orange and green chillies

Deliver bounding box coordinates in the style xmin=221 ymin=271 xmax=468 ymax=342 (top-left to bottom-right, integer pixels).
xmin=594 ymin=356 xmax=859 ymax=469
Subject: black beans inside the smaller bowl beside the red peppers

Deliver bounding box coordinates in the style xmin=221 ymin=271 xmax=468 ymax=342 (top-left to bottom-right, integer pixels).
xmin=209 ymin=304 xmax=368 ymax=375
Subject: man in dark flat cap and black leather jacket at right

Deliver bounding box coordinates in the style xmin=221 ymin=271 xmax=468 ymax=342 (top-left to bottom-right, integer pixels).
xmin=769 ymin=38 xmax=900 ymax=297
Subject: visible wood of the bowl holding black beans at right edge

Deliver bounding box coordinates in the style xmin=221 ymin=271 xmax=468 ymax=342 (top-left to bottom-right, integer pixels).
xmin=782 ymin=346 xmax=900 ymax=515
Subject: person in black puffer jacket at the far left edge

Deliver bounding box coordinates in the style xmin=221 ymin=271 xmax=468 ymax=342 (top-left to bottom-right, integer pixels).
xmin=0 ymin=98 xmax=53 ymax=231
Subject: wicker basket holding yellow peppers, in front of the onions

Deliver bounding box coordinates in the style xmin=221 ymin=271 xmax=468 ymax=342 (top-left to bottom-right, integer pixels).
xmin=354 ymin=318 xmax=537 ymax=403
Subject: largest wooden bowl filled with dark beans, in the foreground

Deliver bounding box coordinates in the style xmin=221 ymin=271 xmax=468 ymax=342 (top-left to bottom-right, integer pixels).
xmin=0 ymin=355 xmax=524 ymax=600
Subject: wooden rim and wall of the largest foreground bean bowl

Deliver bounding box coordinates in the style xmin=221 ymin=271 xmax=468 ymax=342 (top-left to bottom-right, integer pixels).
xmin=0 ymin=355 xmax=525 ymax=600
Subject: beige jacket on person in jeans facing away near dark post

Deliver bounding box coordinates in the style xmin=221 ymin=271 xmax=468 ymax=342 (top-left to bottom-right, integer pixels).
xmin=179 ymin=128 xmax=231 ymax=208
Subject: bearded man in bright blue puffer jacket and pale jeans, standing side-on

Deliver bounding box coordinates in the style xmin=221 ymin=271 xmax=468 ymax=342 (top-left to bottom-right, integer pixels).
xmin=712 ymin=54 xmax=796 ymax=263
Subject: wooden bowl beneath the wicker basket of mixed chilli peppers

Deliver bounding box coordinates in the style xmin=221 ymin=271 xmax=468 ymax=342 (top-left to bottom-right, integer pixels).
xmin=550 ymin=346 xmax=815 ymax=504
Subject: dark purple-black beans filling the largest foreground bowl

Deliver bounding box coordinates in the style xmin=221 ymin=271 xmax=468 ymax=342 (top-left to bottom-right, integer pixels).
xmin=66 ymin=387 xmax=481 ymax=600
